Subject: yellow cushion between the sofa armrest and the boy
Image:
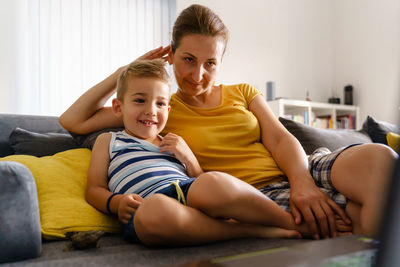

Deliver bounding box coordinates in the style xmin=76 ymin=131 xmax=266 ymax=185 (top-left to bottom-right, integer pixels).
xmin=0 ymin=149 xmax=121 ymax=239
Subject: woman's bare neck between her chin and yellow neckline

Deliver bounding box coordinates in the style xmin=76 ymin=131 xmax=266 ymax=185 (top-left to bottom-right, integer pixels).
xmin=176 ymin=85 xmax=222 ymax=108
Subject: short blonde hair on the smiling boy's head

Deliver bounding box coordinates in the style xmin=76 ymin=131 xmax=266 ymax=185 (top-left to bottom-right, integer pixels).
xmin=117 ymin=59 xmax=171 ymax=101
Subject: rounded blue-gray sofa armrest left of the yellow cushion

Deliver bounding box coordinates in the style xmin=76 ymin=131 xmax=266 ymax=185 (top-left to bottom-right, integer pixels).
xmin=0 ymin=161 xmax=42 ymax=263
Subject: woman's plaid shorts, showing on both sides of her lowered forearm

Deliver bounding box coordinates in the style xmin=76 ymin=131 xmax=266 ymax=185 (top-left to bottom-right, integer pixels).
xmin=260 ymin=144 xmax=357 ymax=212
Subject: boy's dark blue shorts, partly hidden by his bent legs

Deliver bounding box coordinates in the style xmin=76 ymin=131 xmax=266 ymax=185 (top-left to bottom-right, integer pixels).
xmin=122 ymin=178 xmax=196 ymax=243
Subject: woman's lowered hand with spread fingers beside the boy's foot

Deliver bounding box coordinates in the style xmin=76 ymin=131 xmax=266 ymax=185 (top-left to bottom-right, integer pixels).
xmin=290 ymin=180 xmax=351 ymax=239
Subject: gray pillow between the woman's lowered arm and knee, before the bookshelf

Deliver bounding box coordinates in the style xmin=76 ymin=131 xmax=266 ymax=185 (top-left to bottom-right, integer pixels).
xmin=279 ymin=117 xmax=372 ymax=155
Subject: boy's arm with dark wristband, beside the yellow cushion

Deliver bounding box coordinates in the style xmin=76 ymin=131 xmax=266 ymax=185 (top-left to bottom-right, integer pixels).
xmin=86 ymin=133 xmax=143 ymax=224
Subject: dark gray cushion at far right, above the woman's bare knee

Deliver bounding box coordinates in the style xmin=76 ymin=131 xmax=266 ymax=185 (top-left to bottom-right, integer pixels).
xmin=362 ymin=116 xmax=400 ymax=145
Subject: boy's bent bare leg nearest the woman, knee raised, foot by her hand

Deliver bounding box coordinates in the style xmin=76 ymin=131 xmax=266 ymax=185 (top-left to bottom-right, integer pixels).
xmin=187 ymin=172 xmax=308 ymax=235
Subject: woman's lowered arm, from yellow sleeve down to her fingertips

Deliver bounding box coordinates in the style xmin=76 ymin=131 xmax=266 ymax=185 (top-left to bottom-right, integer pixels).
xmin=249 ymin=95 xmax=348 ymax=239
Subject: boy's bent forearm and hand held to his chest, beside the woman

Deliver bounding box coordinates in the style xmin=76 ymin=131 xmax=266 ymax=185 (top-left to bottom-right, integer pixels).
xmin=160 ymin=133 xmax=203 ymax=177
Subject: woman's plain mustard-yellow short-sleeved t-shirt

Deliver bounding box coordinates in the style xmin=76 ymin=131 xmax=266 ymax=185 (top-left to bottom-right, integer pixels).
xmin=163 ymin=84 xmax=284 ymax=188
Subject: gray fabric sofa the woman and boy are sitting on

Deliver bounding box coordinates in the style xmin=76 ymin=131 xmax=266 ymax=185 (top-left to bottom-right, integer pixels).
xmin=0 ymin=114 xmax=396 ymax=266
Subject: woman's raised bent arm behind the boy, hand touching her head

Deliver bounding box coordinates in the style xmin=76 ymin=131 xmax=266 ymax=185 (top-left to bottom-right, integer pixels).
xmin=59 ymin=46 xmax=170 ymax=134
